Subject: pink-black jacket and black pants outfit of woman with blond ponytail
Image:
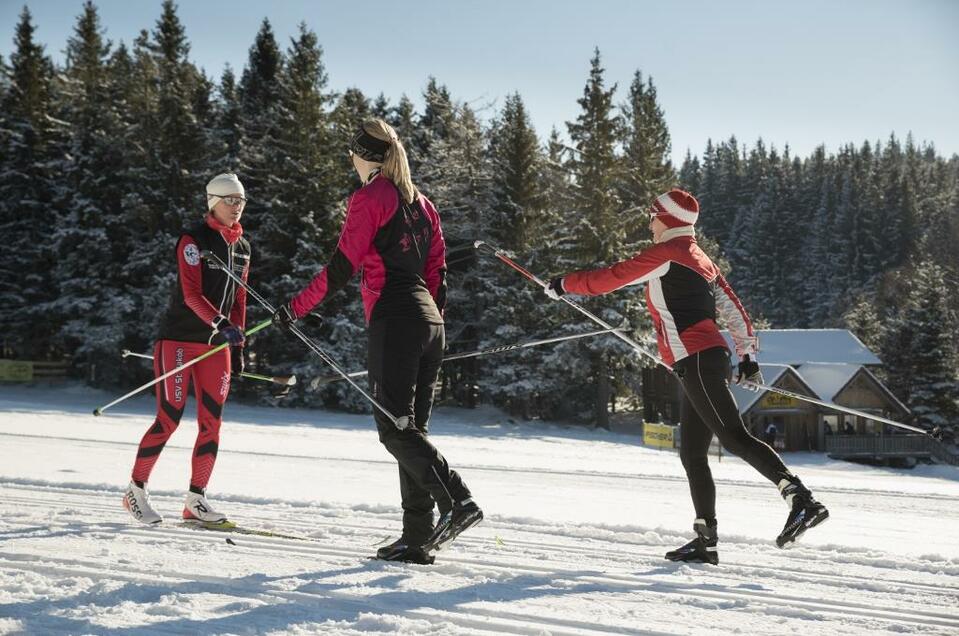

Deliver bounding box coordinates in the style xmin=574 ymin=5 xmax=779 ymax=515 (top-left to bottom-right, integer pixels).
xmin=290 ymin=175 xmax=470 ymax=545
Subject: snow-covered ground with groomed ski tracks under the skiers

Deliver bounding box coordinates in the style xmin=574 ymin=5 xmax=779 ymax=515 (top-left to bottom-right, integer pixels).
xmin=0 ymin=386 xmax=959 ymax=635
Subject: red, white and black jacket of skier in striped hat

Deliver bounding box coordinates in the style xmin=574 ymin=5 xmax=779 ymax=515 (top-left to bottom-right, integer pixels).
xmin=563 ymin=227 xmax=759 ymax=366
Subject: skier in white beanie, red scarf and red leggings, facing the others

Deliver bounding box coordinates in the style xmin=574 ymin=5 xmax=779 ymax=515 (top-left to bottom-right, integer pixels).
xmin=123 ymin=174 xmax=250 ymax=524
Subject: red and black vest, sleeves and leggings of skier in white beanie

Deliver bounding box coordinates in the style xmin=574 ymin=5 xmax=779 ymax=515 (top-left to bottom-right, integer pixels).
xmin=133 ymin=215 xmax=250 ymax=492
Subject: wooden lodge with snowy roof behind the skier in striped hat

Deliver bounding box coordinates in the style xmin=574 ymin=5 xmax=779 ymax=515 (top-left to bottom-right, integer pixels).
xmin=643 ymin=329 xmax=910 ymax=451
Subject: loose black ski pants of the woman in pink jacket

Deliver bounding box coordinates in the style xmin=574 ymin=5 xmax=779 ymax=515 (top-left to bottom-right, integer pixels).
xmin=367 ymin=318 xmax=470 ymax=545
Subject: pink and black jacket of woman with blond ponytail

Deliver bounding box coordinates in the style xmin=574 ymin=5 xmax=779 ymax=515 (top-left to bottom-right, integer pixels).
xmin=290 ymin=175 xmax=446 ymax=324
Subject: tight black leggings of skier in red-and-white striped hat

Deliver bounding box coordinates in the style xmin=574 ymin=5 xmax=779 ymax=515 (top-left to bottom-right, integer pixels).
xmin=673 ymin=347 xmax=790 ymax=520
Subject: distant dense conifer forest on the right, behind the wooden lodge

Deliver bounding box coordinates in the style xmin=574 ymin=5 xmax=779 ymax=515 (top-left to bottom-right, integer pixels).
xmin=680 ymin=136 xmax=959 ymax=425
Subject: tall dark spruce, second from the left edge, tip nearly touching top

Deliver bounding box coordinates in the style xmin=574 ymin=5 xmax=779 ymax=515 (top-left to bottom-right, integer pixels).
xmin=50 ymin=2 xmax=135 ymax=383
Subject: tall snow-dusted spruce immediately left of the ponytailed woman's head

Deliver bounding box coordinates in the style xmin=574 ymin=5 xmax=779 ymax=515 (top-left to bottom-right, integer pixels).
xmin=278 ymin=24 xmax=370 ymax=411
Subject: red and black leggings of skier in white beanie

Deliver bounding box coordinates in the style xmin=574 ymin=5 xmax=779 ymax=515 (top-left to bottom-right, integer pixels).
xmin=133 ymin=340 xmax=230 ymax=490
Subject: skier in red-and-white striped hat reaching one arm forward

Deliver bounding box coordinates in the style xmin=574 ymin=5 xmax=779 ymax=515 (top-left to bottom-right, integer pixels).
xmin=545 ymin=189 xmax=829 ymax=564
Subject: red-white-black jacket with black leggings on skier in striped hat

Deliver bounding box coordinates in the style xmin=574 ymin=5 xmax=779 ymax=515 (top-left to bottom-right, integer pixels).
xmin=563 ymin=227 xmax=789 ymax=522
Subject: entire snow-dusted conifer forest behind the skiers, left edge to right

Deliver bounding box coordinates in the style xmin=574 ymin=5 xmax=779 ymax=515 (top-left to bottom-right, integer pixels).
xmin=0 ymin=0 xmax=959 ymax=424
